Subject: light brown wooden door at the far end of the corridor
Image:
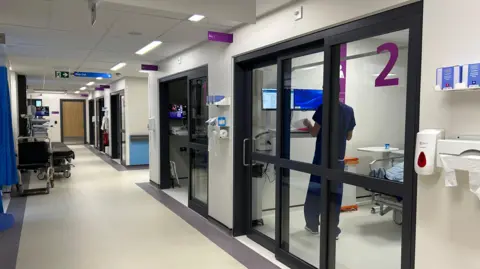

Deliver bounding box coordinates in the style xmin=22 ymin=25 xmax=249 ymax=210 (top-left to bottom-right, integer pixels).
xmin=60 ymin=99 xmax=87 ymax=144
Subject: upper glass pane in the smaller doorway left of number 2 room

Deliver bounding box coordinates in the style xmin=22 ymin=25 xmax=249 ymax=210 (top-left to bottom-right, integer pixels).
xmin=188 ymin=77 xmax=208 ymax=145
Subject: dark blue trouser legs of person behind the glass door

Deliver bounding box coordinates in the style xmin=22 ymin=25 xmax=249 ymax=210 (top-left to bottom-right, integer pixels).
xmin=304 ymin=175 xmax=343 ymax=235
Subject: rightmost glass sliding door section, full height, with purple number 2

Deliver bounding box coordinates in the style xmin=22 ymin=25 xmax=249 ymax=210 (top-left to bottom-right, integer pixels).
xmin=322 ymin=29 xmax=416 ymax=269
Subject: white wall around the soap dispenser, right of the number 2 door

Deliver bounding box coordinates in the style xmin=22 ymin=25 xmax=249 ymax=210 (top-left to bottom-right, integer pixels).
xmin=416 ymin=0 xmax=480 ymax=269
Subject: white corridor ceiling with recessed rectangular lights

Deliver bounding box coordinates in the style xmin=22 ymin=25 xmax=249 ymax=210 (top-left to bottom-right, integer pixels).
xmin=0 ymin=0 xmax=295 ymax=91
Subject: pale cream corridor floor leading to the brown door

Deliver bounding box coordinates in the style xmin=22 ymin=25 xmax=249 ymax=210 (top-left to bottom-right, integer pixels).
xmin=0 ymin=146 xmax=277 ymax=269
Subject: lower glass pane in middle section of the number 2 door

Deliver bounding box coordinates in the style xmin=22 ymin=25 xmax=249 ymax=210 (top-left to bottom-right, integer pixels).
xmin=282 ymin=169 xmax=321 ymax=268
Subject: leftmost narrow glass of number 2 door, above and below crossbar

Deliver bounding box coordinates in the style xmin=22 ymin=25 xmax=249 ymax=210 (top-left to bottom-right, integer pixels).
xmin=251 ymin=65 xmax=277 ymax=239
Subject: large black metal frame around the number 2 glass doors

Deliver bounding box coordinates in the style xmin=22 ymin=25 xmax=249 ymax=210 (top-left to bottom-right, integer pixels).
xmin=233 ymin=2 xmax=423 ymax=269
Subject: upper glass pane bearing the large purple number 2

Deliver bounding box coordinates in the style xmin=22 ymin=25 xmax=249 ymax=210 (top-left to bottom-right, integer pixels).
xmin=339 ymin=30 xmax=409 ymax=182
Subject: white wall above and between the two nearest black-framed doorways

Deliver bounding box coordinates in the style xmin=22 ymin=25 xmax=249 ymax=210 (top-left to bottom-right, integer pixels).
xmin=149 ymin=0 xmax=411 ymax=228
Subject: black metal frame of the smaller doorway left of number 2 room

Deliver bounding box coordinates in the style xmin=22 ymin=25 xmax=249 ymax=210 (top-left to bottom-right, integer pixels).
xmin=159 ymin=65 xmax=208 ymax=217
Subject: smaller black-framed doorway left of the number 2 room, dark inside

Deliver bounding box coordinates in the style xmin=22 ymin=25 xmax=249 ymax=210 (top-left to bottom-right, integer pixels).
xmin=160 ymin=66 xmax=208 ymax=216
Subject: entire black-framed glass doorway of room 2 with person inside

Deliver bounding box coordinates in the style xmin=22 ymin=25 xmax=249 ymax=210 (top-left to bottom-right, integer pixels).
xmin=234 ymin=3 xmax=422 ymax=269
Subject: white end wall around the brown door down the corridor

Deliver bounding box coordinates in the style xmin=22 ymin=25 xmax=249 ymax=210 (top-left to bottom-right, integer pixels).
xmin=27 ymin=93 xmax=88 ymax=142
